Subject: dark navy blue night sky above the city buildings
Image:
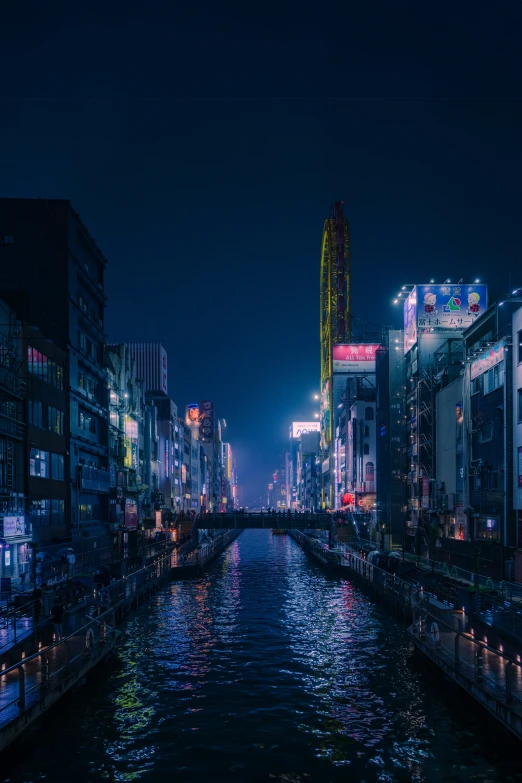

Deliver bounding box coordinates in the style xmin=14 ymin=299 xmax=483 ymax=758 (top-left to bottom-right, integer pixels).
xmin=0 ymin=0 xmax=522 ymax=502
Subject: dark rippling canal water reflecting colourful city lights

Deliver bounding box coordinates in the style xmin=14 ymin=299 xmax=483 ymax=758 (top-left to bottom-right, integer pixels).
xmin=0 ymin=530 xmax=522 ymax=783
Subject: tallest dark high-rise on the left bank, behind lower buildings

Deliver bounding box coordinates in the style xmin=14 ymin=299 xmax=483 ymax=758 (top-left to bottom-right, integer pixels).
xmin=0 ymin=198 xmax=109 ymax=537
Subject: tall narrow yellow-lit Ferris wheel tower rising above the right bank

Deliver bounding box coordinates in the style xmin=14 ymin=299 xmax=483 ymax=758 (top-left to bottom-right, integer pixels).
xmin=320 ymin=201 xmax=352 ymax=508
